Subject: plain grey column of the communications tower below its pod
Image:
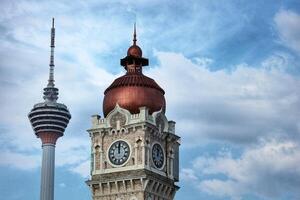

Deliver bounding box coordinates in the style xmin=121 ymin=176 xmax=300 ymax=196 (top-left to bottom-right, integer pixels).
xmin=40 ymin=143 xmax=55 ymax=200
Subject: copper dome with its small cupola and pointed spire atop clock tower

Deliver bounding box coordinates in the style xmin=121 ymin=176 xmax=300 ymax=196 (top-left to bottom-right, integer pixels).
xmin=103 ymin=25 xmax=166 ymax=117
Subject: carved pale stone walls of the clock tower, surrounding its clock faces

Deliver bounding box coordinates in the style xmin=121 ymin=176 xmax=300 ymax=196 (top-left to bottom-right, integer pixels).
xmin=87 ymin=105 xmax=180 ymax=200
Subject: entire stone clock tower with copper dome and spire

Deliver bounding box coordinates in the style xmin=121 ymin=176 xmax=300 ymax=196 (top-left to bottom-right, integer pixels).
xmin=86 ymin=27 xmax=180 ymax=200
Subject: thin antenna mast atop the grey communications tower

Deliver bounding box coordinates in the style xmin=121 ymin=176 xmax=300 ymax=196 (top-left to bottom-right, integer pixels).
xmin=44 ymin=18 xmax=58 ymax=102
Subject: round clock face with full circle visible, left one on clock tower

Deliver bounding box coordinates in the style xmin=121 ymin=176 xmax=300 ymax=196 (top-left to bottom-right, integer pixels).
xmin=108 ymin=140 xmax=130 ymax=165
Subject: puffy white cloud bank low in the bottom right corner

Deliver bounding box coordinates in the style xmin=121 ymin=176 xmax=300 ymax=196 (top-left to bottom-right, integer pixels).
xmin=182 ymin=139 xmax=300 ymax=199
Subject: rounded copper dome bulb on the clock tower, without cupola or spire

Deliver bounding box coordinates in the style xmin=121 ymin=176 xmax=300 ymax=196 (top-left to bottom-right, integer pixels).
xmin=103 ymin=74 xmax=166 ymax=116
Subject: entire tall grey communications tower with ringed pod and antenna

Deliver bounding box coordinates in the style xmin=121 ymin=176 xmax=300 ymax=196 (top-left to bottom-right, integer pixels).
xmin=28 ymin=18 xmax=71 ymax=200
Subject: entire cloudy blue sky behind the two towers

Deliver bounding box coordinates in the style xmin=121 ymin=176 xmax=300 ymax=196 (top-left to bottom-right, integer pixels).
xmin=0 ymin=0 xmax=300 ymax=200
